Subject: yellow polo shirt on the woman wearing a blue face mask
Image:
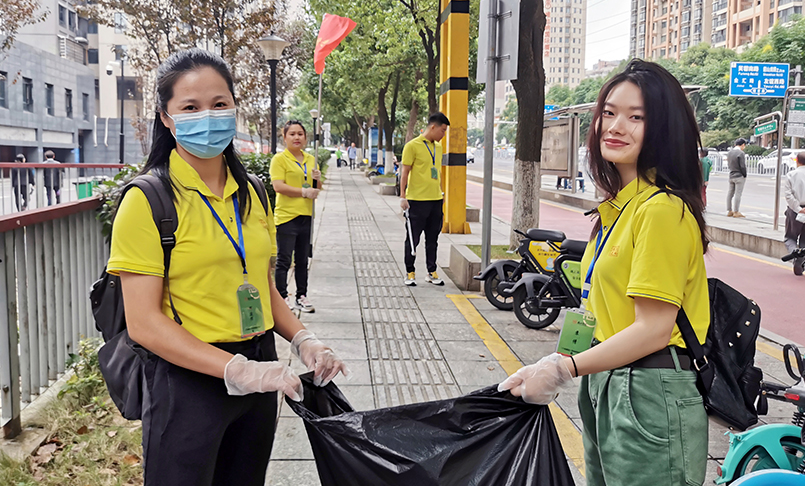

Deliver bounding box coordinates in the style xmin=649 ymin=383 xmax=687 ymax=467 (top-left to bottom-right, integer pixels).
xmin=107 ymin=151 xmax=276 ymax=343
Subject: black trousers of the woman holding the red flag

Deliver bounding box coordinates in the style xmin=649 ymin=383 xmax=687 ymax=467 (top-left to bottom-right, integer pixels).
xmin=274 ymin=216 xmax=313 ymax=299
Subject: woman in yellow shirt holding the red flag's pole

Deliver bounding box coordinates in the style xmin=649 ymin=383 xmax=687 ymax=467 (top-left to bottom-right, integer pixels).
xmin=269 ymin=120 xmax=322 ymax=312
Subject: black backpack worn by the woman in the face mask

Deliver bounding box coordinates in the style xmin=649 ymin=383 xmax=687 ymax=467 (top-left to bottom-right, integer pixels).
xmin=90 ymin=174 xmax=270 ymax=420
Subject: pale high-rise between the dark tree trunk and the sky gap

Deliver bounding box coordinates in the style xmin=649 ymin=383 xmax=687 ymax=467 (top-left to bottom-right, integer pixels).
xmin=542 ymin=0 xmax=587 ymax=89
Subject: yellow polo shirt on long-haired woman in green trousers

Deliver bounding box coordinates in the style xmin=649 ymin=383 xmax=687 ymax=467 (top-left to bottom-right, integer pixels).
xmin=581 ymin=179 xmax=710 ymax=347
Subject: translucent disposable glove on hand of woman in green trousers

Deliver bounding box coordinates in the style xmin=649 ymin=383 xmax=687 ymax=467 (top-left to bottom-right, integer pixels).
xmin=498 ymin=353 xmax=573 ymax=405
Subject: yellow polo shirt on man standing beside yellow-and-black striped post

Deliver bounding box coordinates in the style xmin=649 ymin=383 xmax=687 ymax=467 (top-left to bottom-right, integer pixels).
xmin=403 ymin=135 xmax=444 ymax=201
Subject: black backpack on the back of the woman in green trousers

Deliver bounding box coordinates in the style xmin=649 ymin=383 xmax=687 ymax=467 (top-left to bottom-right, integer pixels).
xmin=677 ymin=278 xmax=768 ymax=430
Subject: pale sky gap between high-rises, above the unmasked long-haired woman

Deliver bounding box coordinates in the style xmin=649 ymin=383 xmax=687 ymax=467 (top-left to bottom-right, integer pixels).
xmin=584 ymin=0 xmax=631 ymax=69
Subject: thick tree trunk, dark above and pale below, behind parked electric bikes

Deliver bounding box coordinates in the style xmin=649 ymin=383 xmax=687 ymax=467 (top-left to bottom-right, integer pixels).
xmin=509 ymin=0 xmax=545 ymax=249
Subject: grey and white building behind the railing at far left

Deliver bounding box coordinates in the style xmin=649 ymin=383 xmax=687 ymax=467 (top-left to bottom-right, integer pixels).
xmin=0 ymin=0 xmax=143 ymax=163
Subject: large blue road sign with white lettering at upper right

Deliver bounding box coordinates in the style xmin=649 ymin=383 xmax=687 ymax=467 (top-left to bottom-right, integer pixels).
xmin=730 ymin=62 xmax=789 ymax=98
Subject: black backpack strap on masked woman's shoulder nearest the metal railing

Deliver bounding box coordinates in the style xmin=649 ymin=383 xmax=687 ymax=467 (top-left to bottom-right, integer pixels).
xmin=120 ymin=174 xmax=182 ymax=325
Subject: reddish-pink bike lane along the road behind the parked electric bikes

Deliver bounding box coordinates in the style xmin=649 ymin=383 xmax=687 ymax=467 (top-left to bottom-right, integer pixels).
xmin=467 ymin=181 xmax=805 ymax=344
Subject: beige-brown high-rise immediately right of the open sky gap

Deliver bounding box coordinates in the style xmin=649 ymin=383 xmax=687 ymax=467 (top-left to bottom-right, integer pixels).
xmin=629 ymin=0 xmax=708 ymax=60
